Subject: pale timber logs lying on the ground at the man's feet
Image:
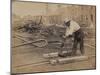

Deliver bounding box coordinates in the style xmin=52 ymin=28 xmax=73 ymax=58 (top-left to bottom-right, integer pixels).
xmin=43 ymin=50 xmax=95 ymax=65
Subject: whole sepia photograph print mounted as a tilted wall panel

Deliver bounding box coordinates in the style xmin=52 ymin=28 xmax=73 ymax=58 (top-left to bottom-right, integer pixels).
xmin=11 ymin=0 xmax=96 ymax=74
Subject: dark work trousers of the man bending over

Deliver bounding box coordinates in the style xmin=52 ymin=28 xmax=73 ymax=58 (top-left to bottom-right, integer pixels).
xmin=72 ymin=29 xmax=85 ymax=55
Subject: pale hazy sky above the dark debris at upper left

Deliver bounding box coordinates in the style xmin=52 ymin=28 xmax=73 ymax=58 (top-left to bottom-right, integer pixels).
xmin=12 ymin=1 xmax=66 ymax=16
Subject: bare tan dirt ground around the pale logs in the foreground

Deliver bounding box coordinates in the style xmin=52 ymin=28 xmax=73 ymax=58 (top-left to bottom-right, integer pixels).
xmin=12 ymin=31 xmax=96 ymax=73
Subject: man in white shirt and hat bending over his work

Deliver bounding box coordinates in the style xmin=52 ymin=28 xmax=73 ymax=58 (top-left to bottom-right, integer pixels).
xmin=59 ymin=20 xmax=84 ymax=57
